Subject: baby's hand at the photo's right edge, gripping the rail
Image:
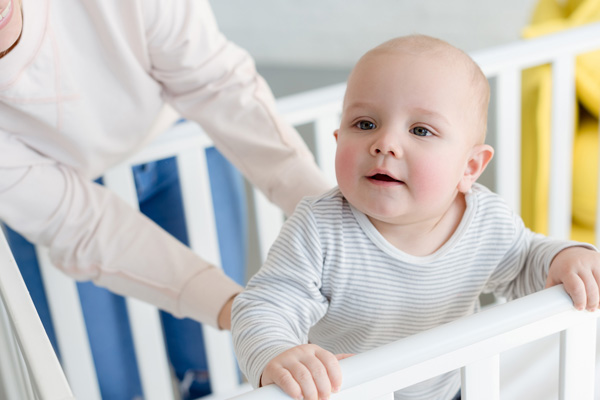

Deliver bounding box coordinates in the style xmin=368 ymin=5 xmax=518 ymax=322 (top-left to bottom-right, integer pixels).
xmin=546 ymin=247 xmax=600 ymax=311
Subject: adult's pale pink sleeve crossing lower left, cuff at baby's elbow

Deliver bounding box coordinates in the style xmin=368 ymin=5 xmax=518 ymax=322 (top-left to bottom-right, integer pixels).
xmin=0 ymin=131 xmax=241 ymax=326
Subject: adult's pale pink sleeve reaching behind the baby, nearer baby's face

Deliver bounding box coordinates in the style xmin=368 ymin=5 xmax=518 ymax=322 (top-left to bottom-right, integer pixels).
xmin=144 ymin=0 xmax=334 ymax=215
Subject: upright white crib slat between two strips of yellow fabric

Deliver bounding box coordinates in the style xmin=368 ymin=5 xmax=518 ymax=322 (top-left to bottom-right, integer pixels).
xmin=548 ymin=56 xmax=575 ymax=239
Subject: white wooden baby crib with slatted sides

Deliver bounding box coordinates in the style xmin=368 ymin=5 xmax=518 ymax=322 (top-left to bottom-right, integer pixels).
xmin=0 ymin=24 xmax=600 ymax=400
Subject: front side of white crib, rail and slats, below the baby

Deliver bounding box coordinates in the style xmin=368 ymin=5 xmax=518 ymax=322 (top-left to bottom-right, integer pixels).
xmin=229 ymin=286 xmax=600 ymax=400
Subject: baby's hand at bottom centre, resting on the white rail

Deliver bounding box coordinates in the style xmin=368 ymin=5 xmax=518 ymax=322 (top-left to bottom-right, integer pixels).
xmin=260 ymin=344 xmax=351 ymax=400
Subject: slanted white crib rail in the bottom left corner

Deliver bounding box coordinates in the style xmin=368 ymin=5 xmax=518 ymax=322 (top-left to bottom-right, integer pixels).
xmin=0 ymin=231 xmax=74 ymax=400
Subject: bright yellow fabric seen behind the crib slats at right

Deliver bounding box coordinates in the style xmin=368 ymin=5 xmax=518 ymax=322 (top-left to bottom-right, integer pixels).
xmin=521 ymin=0 xmax=600 ymax=243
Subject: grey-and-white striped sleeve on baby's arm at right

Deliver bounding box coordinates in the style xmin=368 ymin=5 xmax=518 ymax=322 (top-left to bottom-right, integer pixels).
xmin=485 ymin=215 xmax=594 ymax=300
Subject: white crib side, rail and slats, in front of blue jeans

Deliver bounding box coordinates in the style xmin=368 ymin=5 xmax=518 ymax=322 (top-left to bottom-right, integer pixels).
xmin=28 ymin=122 xmax=240 ymax=400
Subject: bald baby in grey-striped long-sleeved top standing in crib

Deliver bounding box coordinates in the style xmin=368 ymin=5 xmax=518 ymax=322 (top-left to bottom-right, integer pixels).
xmin=232 ymin=35 xmax=600 ymax=400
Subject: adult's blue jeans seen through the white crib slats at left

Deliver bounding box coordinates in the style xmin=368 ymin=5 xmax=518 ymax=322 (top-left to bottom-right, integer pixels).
xmin=7 ymin=148 xmax=246 ymax=400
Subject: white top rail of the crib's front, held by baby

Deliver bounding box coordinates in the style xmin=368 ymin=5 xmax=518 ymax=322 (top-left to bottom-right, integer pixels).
xmin=229 ymin=286 xmax=600 ymax=400
